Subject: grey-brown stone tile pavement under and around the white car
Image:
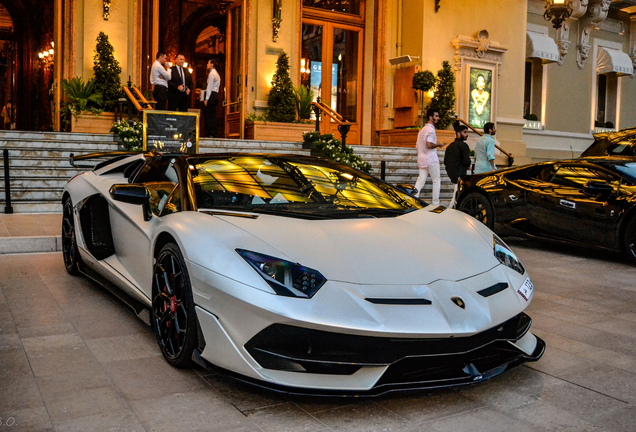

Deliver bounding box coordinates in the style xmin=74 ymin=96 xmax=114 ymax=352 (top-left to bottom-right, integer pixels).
xmin=0 ymin=240 xmax=636 ymax=432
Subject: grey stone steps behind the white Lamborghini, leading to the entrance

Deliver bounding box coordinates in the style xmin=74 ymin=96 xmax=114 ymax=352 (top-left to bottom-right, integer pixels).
xmin=0 ymin=131 xmax=453 ymax=213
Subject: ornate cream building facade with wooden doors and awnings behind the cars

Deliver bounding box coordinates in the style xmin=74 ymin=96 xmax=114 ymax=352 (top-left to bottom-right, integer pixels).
xmin=0 ymin=0 xmax=636 ymax=163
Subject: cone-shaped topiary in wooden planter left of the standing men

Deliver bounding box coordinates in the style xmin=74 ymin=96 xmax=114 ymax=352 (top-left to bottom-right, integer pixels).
xmin=71 ymin=32 xmax=122 ymax=133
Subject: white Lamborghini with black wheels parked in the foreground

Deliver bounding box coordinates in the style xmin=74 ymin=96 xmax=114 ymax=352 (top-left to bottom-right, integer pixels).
xmin=62 ymin=153 xmax=545 ymax=395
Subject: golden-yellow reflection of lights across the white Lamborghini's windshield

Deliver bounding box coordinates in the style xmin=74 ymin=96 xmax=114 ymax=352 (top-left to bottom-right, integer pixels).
xmin=191 ymin=156 xmax=422 ymax=210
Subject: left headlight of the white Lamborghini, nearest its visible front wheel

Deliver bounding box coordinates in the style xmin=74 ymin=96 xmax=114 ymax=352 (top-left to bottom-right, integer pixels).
xmin=236 ymin=249 xmax=327 ymax=298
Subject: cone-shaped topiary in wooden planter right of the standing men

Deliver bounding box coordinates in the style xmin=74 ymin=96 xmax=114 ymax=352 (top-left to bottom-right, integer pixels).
xmin=245 ymin=52 xmax=311 ymax=142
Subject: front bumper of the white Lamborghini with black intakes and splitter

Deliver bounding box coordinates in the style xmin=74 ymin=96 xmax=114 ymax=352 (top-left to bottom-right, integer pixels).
xmin=197 ymin=308 xmax=545 ymax=396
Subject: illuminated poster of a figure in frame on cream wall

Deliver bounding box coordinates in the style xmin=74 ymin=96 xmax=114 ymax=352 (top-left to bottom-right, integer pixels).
xmin=468 ymin=67 xmax=493 ymax=129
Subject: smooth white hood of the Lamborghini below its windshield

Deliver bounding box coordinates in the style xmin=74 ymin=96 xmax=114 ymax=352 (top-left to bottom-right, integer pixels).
xmin=220 ymin=206 xmax=499 ymax=285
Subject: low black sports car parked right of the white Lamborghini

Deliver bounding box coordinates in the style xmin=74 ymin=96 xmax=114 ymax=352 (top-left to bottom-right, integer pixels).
xmin=457 ymin=156 xmax=636 ymax=264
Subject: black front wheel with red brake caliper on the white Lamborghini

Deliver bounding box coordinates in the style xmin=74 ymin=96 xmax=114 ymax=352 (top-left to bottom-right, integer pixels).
xmin=152 ymin=243 xmax=197 ymax=368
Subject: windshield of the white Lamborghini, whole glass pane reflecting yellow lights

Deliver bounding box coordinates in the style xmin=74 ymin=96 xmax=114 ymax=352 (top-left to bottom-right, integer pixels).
xmin=188 ymin=156 xmax=425 ymax=219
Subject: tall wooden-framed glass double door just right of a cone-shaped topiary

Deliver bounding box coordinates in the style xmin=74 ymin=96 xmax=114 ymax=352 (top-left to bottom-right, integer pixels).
xmin=300 ymin=20 xmax=362 ymax=144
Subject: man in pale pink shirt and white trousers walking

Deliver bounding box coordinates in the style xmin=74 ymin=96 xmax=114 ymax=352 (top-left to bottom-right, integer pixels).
xmin=415 ymin=109 xmax=444 ymax=206
